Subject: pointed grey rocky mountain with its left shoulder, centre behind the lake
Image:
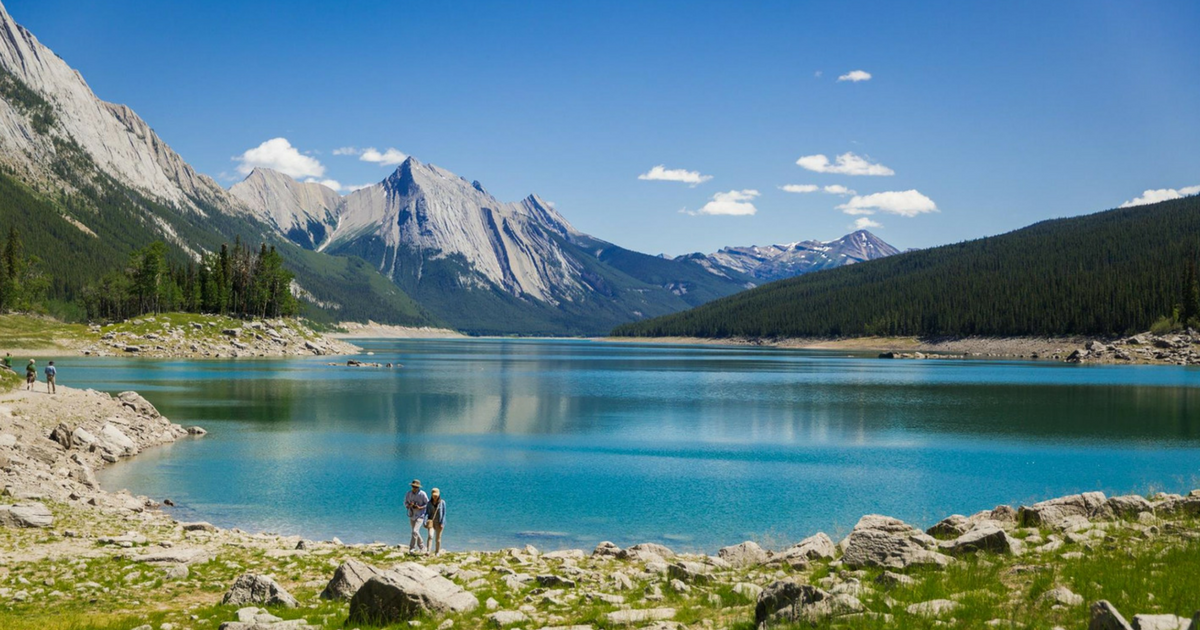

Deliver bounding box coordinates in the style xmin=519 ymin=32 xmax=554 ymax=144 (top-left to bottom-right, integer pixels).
xmin=230 ymin=157 xmax=748 ymax=335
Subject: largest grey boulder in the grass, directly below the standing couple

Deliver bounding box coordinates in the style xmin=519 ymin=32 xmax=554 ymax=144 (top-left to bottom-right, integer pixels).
xmin=349 ymin=563 xmax=479 ymax=625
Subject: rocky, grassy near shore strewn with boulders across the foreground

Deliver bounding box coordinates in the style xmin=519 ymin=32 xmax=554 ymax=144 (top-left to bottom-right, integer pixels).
xmin=0 ymin=388 xmax=1200 ymax=630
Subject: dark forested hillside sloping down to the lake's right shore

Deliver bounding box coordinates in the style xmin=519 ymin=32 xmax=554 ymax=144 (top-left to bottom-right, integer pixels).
xmin=613 ymin=197 xmax=1200 ymax=338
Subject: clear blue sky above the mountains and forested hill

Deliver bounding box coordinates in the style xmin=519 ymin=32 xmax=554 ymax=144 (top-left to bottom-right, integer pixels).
xmin=6 ymin=0 xmax=1200 ymax=254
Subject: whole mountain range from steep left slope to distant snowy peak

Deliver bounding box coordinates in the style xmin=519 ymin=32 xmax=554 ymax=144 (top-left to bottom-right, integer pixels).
xmin=0 ymin=5 xmax=895 ymax=335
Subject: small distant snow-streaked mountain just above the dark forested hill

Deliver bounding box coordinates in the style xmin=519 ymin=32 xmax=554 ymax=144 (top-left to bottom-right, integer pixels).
xmin=680 ymin=229 xmax=900 ymax=284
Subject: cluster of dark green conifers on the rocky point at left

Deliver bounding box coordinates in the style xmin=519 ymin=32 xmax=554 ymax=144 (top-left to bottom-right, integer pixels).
xmin=83 ymin=240 xmax=300 ymax=320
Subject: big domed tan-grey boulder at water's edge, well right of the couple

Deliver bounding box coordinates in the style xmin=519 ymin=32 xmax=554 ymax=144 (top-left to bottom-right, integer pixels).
xmin=841 ymin=515 xmax=953 ymax=569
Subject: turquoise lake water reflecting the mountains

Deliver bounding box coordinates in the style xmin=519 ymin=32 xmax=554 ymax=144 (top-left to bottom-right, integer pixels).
xmin=59 ymin=340 xmax=1200 ymax=552
